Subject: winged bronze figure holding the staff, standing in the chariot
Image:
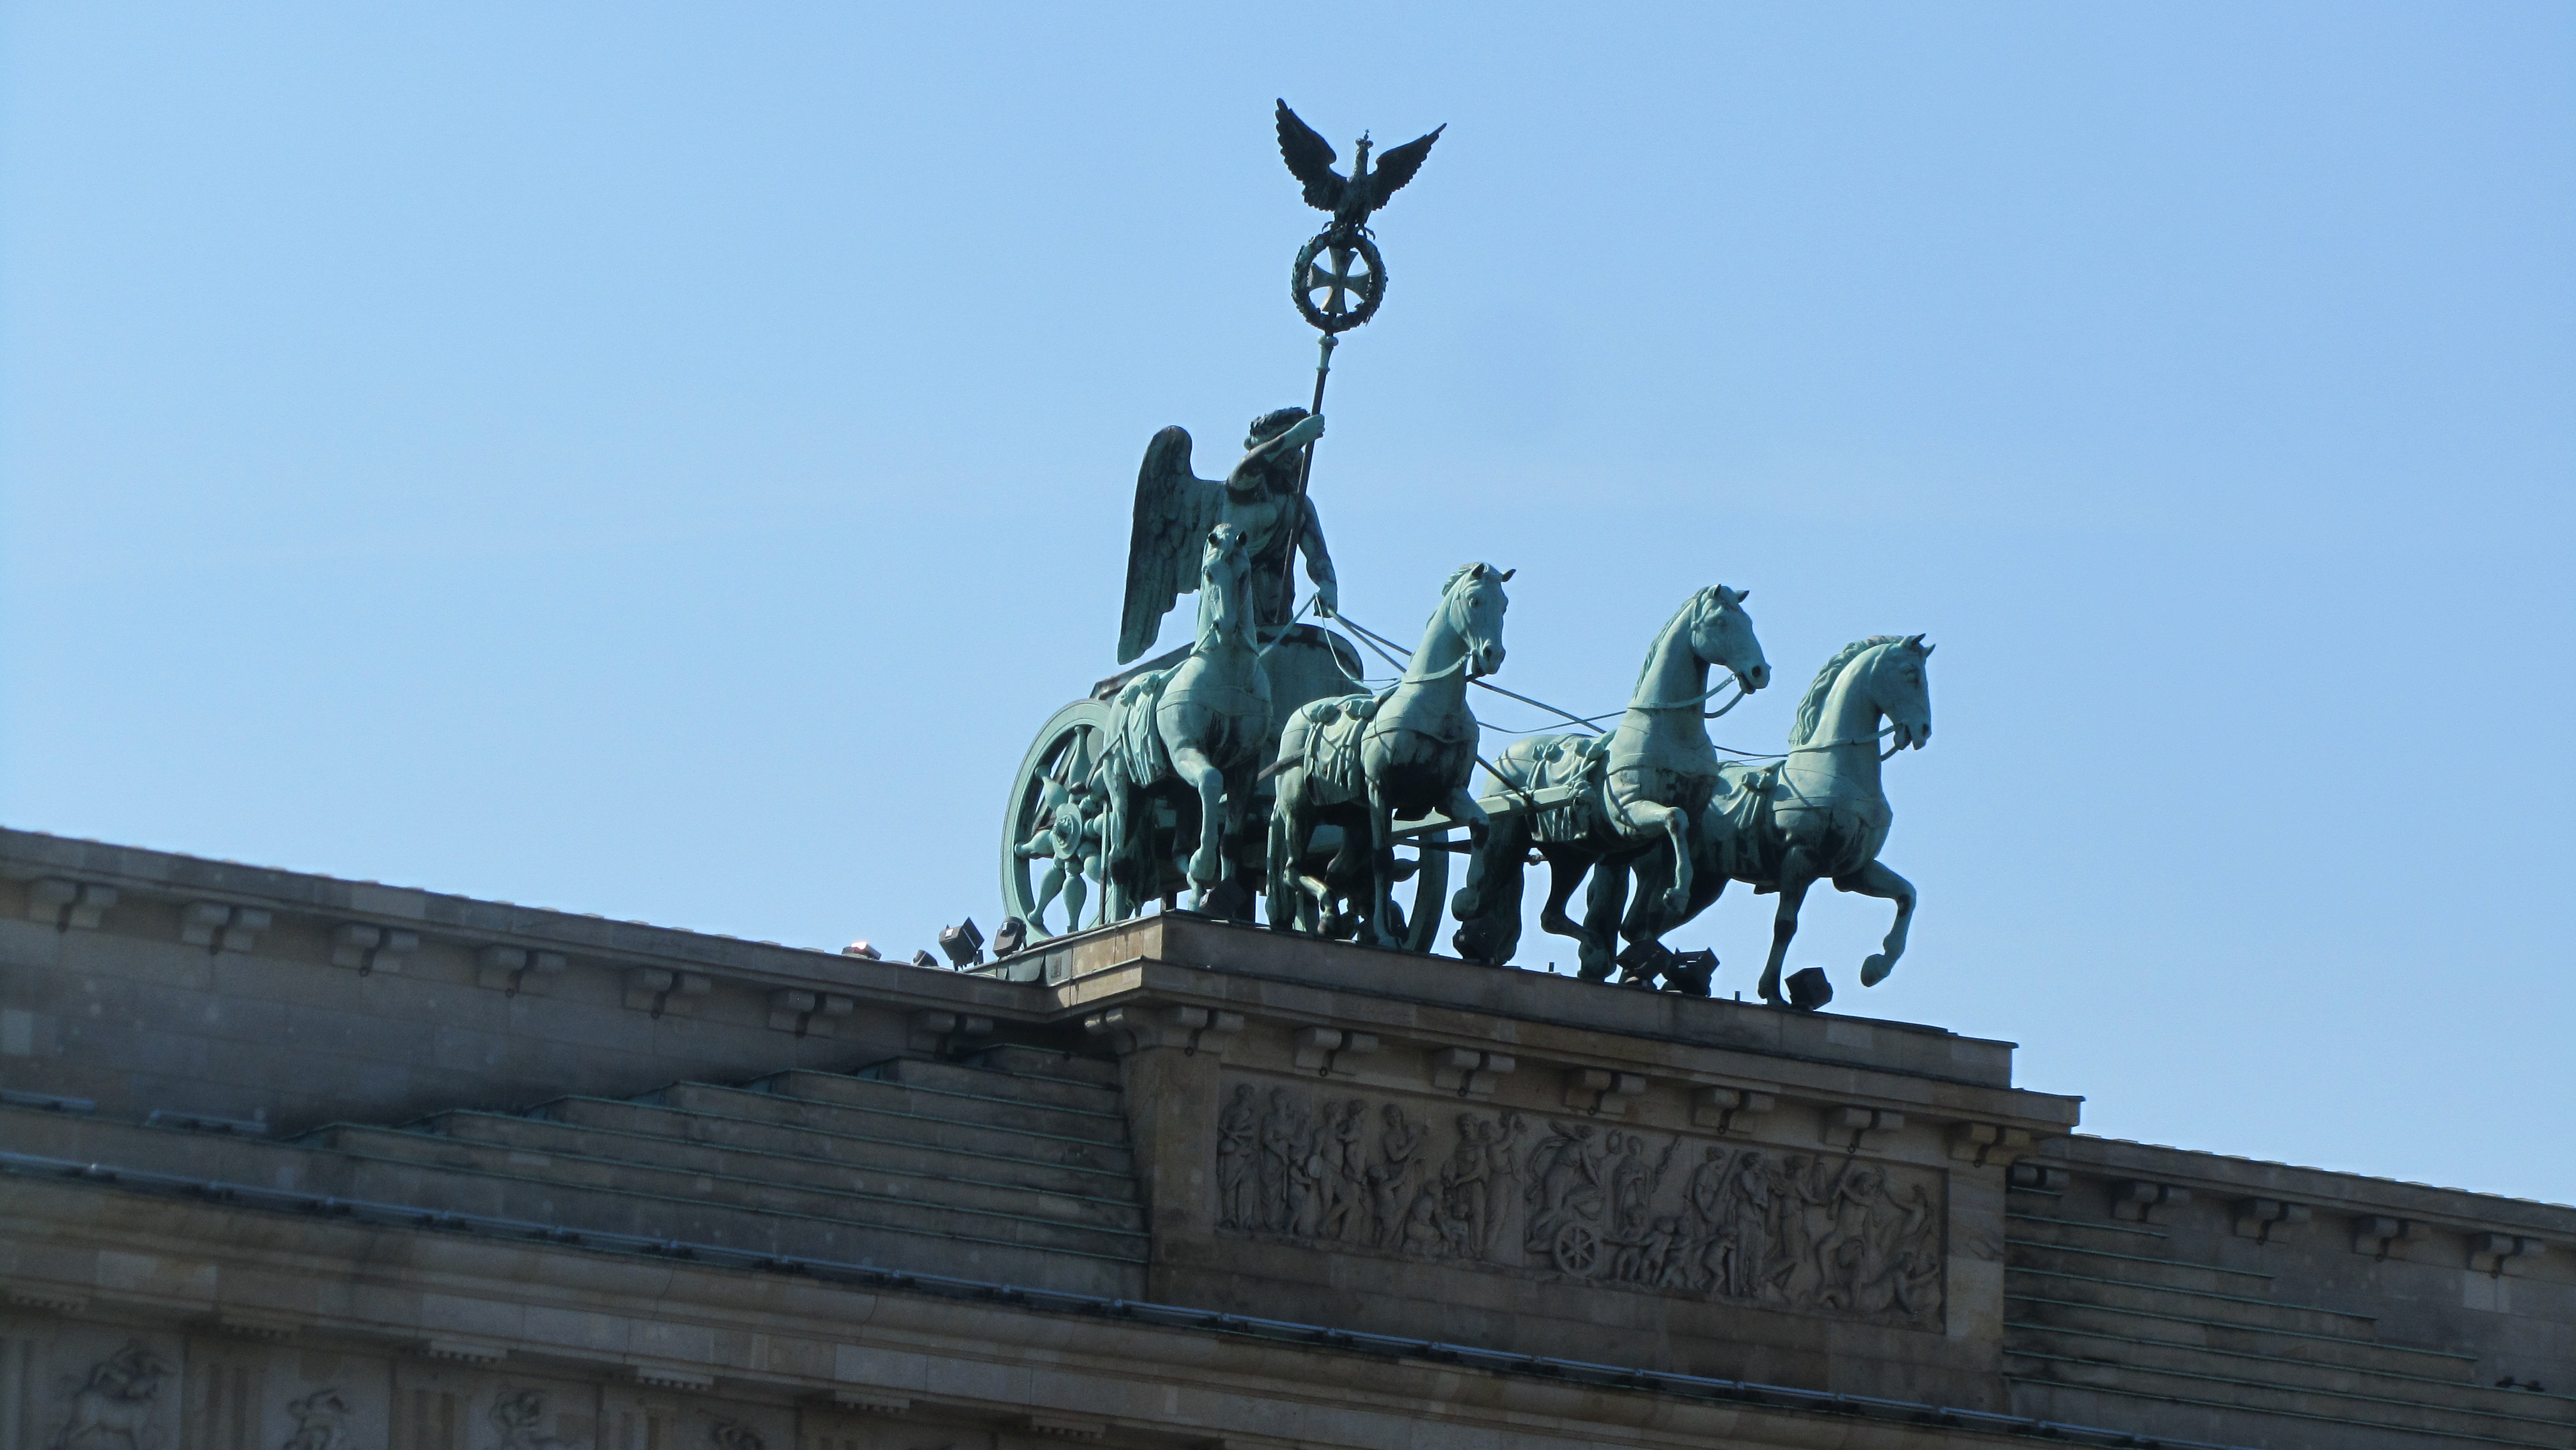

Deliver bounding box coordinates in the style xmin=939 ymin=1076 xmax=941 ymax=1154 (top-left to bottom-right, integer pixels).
xmin=1118 ymin=407 xmax=1337 ymax=664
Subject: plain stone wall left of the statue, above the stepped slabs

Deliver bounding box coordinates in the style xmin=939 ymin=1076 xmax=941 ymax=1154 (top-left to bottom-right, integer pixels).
xmin=0 ymin=832 xmax=1048 ymax=1133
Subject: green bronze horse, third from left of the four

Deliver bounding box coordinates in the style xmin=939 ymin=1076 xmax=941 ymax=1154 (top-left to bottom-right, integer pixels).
xmin=1453 ymin=585 xmax=1770 ymax=981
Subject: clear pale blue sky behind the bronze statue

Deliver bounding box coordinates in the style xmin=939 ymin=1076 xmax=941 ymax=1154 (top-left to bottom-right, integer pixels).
xmin=0 ymin=5 xmax=2576 ymax=1200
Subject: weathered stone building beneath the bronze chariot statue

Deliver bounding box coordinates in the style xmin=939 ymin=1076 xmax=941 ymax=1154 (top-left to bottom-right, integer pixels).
xmin=0 ymin=832 xmax=2576 ymax=1450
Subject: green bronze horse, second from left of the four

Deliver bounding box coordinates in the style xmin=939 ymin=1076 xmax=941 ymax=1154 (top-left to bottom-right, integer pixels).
xmin=1270 ymin=564 xmax=1512 ymax=945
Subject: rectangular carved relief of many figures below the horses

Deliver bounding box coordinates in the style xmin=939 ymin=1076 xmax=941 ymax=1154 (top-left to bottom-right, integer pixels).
xmin=1216 ymin=1079 xmax=1945 ymax=1329
